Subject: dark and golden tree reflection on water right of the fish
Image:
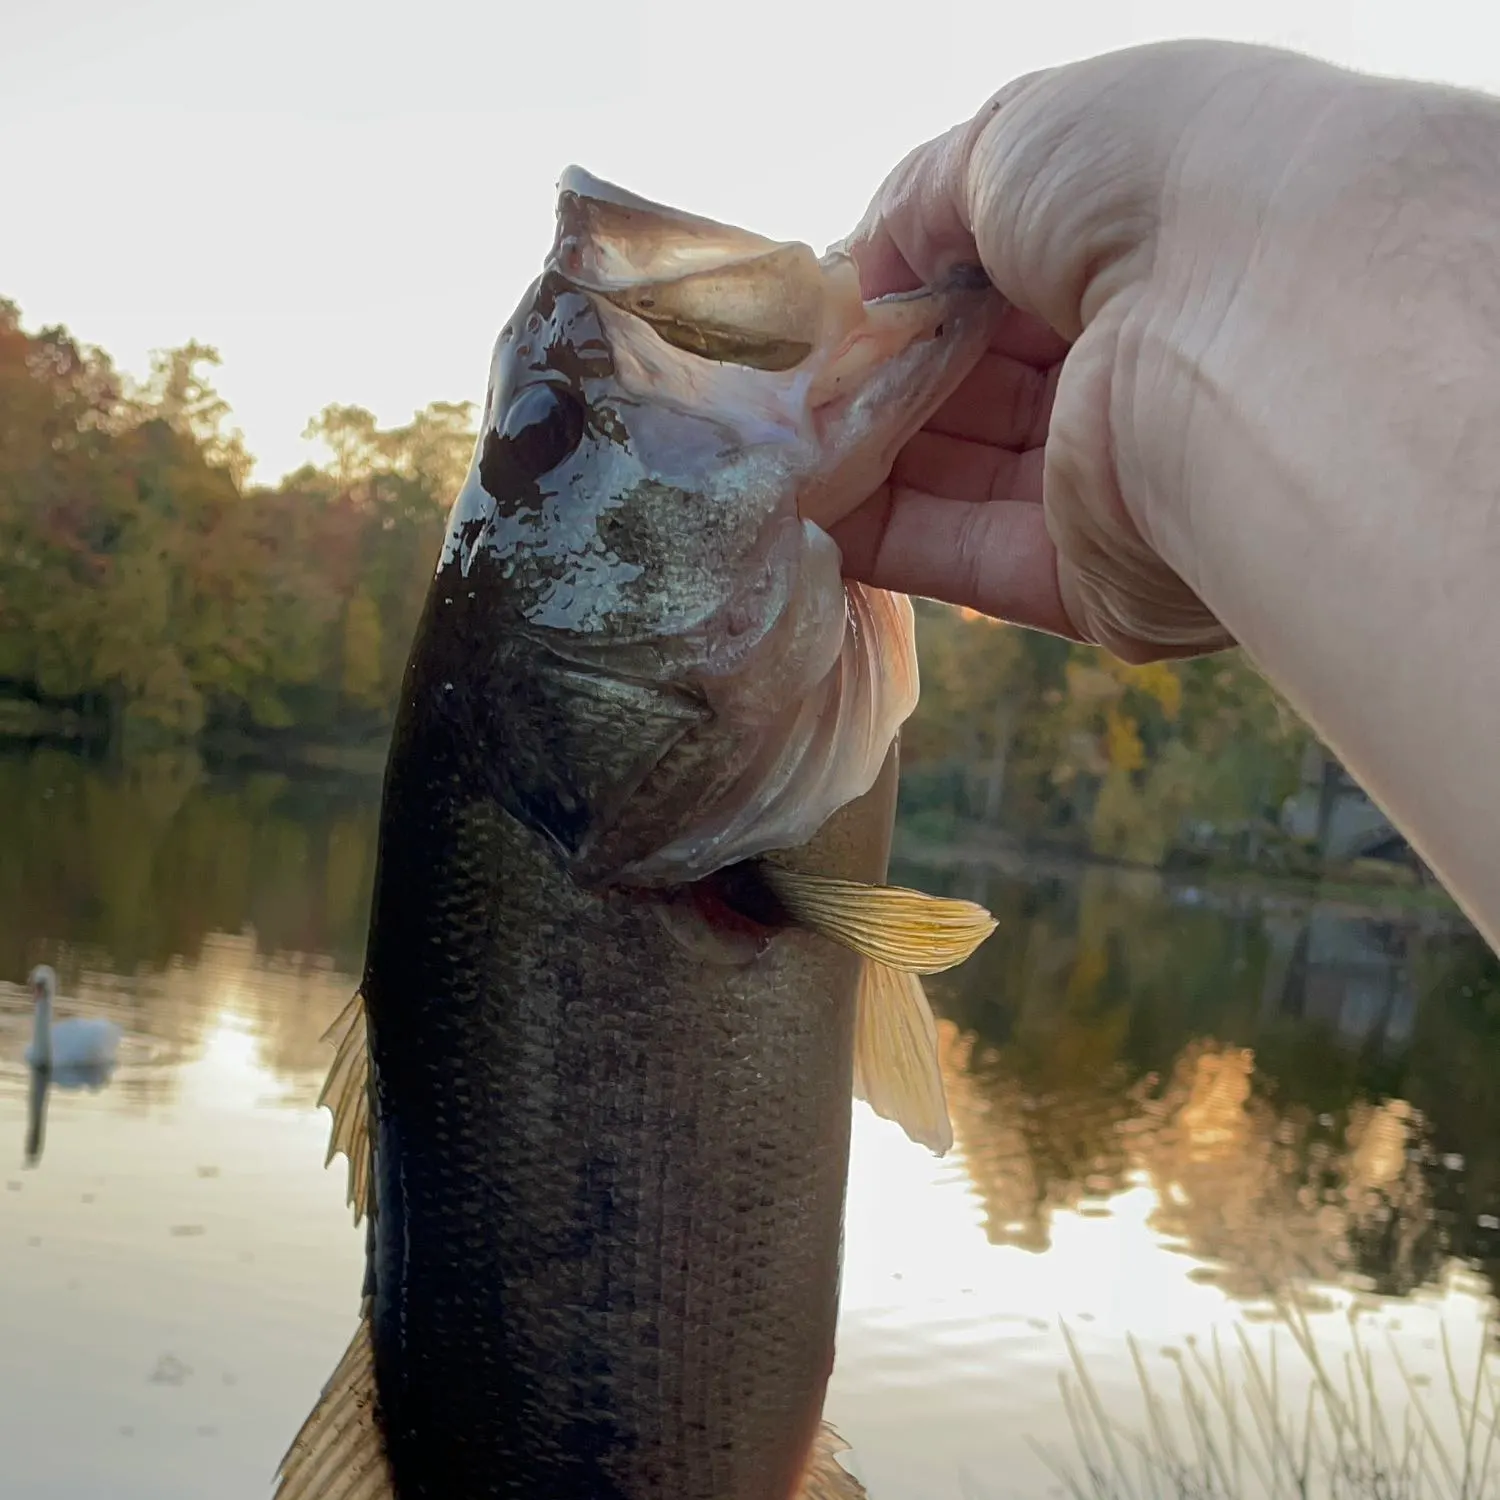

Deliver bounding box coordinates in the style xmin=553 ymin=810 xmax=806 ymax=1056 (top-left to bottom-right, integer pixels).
xmin=914 ymin=870 xmax=1500 ymax=1301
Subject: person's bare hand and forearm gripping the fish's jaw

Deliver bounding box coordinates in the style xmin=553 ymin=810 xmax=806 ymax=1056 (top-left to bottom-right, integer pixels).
xmin=836 ymin=42 xmax=1500 ymax=945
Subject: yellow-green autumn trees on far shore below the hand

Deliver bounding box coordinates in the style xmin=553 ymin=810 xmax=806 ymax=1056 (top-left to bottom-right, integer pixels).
xmin=903 ymin=591 xmax=1307 ymax=864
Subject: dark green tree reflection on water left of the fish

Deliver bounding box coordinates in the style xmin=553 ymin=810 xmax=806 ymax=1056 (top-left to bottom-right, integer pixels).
xmin=0 ymin=750 xmax=378 ymax=993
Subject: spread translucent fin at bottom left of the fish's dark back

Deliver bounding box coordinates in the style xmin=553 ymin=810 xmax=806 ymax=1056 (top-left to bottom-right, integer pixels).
xmin=276 ymin=1305 xmax=396 ymax=1500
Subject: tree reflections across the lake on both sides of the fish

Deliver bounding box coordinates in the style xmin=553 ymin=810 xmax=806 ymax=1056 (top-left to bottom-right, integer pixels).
xmin=0 ymin=752 xmax=1500 ymax=1332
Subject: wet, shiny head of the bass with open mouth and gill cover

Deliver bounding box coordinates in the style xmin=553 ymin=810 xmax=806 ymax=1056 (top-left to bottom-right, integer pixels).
xmin=434 ymin=168 xmax=998 ymax=885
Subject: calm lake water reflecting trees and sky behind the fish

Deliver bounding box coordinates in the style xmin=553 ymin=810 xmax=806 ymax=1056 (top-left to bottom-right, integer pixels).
xmin=0 ymin=752 xmax=1500 ymax=1500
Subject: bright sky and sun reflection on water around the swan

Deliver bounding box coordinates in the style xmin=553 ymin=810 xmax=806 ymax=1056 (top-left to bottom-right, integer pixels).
xmin=0 ymin=933 xmax=363 ymax=1500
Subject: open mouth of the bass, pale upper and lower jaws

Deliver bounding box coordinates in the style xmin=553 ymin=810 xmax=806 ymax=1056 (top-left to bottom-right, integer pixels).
xmin=551 ymin=167 xmax=1002 ymax=530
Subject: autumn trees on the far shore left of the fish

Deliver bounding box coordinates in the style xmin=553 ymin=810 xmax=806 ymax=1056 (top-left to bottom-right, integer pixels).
xmin=0 ymin=302 xmax=474 ymax=750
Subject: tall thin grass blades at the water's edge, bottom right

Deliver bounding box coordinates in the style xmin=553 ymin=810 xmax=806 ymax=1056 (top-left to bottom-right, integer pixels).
xmin=1034 ymin=1308 xmax=1500 ymax=1500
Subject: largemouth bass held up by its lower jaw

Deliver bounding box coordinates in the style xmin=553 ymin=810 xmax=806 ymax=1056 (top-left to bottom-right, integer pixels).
xmin=278 ymin=170 xmax=995 ymax=1500
